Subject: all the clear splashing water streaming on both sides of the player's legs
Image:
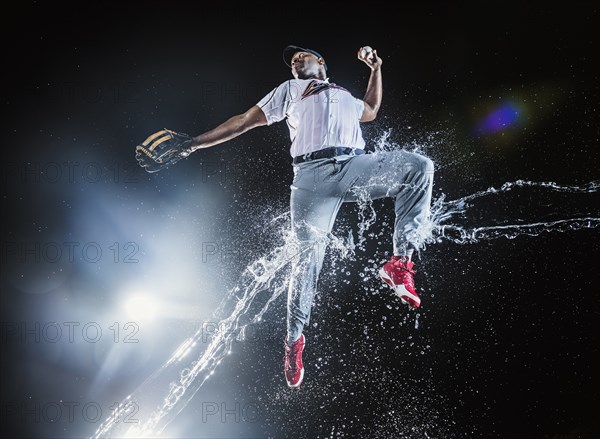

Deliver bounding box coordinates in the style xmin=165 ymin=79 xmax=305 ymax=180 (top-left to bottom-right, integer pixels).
xmin=93 ymin=170 xmax=600 ymax=438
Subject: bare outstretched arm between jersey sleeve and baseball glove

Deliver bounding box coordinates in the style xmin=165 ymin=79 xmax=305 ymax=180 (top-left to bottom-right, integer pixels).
xmin=191 ymin=105 xmax=267 ymax=152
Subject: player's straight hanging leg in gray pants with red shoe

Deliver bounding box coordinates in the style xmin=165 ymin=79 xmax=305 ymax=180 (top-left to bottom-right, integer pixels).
xmin=284 ymin=160 xmax=342 ymax=387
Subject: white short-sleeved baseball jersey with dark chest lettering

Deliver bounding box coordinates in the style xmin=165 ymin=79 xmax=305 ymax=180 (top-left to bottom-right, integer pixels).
xmin=257 ymin=79 xmax=365 ymax=157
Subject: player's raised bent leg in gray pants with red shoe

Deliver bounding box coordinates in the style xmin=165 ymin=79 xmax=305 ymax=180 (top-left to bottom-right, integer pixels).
xmin=344 ymin=151 xmax=434 ymax=308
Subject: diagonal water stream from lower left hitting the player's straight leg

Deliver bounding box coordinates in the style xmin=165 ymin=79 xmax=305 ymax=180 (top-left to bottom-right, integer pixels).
xmin=92 ymin=223 xmax=352 ymax=438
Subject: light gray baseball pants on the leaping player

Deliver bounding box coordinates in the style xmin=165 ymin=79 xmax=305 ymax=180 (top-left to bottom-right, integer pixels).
xmin=287 ymin=150 xmax=434 ymax=343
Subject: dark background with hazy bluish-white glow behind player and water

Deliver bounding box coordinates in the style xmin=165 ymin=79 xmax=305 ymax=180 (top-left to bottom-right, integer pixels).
xmin=0 ymin=1 xmax=600 ymax=438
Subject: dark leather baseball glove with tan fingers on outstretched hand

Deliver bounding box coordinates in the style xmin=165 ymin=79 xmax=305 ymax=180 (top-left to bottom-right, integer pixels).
xmin=135 ymin=128 xmax=192 ymax=172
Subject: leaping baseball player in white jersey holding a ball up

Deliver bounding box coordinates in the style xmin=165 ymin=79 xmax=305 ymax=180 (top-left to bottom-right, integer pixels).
xmin=136 ymin=46 xmax=434 ymax=388
